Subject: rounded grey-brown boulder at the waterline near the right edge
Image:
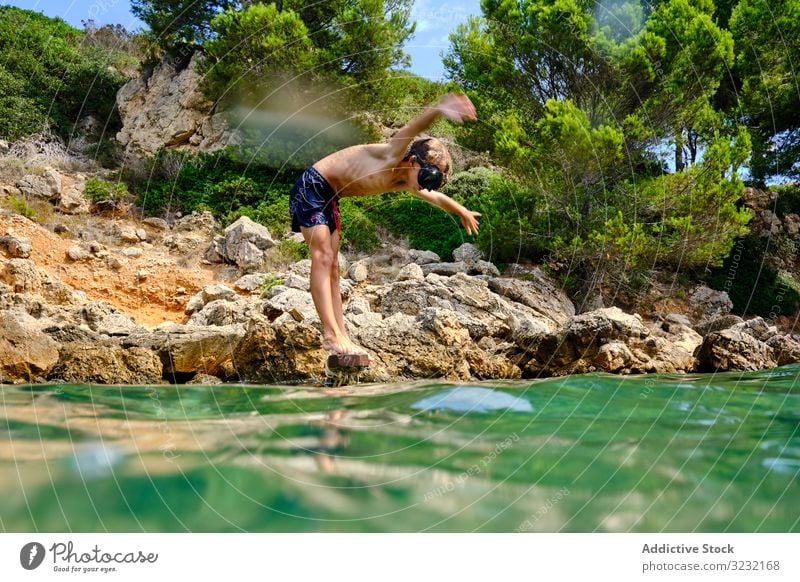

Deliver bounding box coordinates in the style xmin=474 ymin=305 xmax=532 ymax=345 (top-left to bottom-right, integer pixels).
xmin=697 ymin=329 xmax=777 ymax=372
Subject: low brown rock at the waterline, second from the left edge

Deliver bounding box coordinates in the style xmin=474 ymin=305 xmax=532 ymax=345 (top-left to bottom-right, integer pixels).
xmin=49 ymin=342 xmax=163 ymax=384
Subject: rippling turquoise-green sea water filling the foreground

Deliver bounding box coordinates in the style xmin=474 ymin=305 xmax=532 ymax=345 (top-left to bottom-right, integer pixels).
xmin=0 ymin=366 xmax=800 ymax=532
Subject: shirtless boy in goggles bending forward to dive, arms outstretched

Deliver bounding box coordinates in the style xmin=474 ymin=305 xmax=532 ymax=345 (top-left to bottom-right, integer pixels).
xmin=289 ymin=93 xmax=480 ymax=355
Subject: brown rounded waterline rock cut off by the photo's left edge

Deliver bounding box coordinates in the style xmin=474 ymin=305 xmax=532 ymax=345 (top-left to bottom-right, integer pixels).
xmin=0 ymin=311 xmax=58 ymax=382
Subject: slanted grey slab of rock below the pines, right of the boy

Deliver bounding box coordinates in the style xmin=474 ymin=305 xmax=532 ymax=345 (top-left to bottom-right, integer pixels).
xmin=489 ymin=268 xmax=575 ymax=325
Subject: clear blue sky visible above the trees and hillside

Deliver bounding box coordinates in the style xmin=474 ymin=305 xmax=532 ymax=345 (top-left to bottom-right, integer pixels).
xmin=6 ymin=0 xmax=480 ymax=80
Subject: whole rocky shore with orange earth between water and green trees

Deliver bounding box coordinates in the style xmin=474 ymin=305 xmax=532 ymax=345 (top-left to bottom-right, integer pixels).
xmin=0 ymin=170 xmax=800 ymax=384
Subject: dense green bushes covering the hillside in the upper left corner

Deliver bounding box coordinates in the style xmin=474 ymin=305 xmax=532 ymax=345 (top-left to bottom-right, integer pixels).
xmin=0 ymin=6 xmax=125 ymax=139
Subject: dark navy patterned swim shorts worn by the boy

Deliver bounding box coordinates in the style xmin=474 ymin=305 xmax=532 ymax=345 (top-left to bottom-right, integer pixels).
xmin=289 ymin=167 xmax=342 ymax=234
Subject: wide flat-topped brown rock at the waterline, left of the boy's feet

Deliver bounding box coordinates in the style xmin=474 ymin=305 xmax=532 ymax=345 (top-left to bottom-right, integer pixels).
xmin=122 ymin=324 xmax=244 ymax=376
